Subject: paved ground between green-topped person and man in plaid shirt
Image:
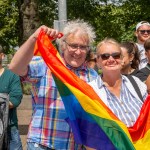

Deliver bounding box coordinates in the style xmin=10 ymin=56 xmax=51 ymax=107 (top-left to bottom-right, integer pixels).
xmin=17 ymin=95 xmax=32 ymax=150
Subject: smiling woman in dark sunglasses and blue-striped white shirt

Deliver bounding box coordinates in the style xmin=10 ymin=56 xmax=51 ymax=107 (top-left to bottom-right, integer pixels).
xmin=89 ymin=39 xmax=147 ymax=127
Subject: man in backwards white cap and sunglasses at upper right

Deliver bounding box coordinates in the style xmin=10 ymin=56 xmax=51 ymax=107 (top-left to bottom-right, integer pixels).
xmin=135 ymin=21 xmax=150 ymax=69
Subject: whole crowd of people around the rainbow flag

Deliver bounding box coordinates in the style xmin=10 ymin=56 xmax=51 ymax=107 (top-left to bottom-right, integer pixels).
xmin=0 ymin=20 xmax=150 ymax=150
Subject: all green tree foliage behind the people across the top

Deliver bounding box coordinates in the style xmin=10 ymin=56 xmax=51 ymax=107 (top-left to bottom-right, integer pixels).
xmin=0 ymin=0 xmax=150 ymax=53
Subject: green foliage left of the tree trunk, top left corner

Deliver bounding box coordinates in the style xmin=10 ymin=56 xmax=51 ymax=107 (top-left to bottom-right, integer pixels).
xmin=0 ymin=0 xmax=19 ymax=53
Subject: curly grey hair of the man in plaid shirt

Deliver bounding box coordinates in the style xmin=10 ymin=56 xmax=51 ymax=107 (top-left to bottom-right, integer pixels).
xmin=57 ymin=19 xmax=96 ymax=49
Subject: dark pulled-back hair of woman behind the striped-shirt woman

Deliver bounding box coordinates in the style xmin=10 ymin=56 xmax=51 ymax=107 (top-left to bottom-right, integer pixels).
xmin=120 ymin=42 xmax=140 ymax=69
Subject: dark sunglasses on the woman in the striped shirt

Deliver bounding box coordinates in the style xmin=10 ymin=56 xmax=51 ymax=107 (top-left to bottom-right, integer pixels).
xmin=98 ymin=52 xmax=121 ymax=60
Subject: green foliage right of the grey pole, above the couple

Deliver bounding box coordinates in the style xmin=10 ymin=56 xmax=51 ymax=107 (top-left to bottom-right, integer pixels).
xmin=67 ymin=0 xmax=150 ymax=42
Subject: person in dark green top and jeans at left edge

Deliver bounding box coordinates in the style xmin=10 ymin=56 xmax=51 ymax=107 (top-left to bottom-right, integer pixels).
xmin=0 ymin=46 xmax=23 ymax=150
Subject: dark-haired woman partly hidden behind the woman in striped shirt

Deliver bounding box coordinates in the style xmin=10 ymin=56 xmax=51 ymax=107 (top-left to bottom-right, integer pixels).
xmin=120 ymin=42 xmax=140 ymax=75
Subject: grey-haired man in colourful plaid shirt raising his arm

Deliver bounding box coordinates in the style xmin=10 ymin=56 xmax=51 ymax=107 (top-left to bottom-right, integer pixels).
xmin=9 ymin=20 xmax=97 ymax=150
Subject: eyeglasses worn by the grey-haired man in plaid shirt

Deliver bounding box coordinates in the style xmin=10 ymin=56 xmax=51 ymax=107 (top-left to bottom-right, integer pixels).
xmin=64 ymin=41 xmax=89 ymax=52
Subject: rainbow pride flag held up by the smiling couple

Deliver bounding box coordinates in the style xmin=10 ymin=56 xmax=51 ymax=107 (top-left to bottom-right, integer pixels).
xmin=35 ymin=31 xmax=150 ymax=150
